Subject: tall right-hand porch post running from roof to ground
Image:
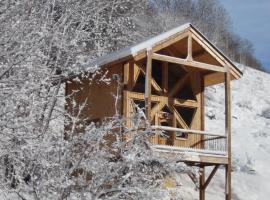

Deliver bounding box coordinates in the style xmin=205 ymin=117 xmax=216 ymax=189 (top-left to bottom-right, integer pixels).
xmin=225 ymin=65 xmax=232 ymax=200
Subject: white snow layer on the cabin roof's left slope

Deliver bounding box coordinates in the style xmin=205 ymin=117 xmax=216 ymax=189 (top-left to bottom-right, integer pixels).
xmin=85 ymin=23 xmax=191 ymax=70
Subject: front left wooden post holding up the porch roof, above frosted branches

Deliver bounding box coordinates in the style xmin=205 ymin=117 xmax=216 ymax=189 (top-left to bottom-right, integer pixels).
xmin=144 ymin=50 xmax=152 ymax=121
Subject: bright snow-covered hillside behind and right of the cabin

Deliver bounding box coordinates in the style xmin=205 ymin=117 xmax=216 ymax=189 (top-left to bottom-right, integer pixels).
xmin=179 ymin=66 xmax=270 ymax=200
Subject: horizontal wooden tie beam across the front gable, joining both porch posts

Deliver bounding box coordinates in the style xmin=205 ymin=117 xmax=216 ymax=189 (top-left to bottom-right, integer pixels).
xmin=153 ymin=53 xmax=225 ymax=72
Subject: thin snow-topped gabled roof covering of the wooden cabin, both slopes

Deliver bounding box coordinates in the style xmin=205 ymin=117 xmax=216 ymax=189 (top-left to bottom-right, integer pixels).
xmin=83 ymin=23 xmax=242 ymax=79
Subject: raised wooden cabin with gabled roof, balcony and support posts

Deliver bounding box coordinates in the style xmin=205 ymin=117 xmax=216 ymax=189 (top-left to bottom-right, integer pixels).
xmin=66 ymin=24 xmax=242 ymax=200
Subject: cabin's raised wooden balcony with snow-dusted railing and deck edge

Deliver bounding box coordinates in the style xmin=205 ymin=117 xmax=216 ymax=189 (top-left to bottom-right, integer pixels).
xmin=150 ymin=126 xmax=228 ymax=163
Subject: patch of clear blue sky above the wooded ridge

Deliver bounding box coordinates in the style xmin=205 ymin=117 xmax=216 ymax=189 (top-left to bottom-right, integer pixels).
xmin=220 ymin=0 xmax=270 ymax=71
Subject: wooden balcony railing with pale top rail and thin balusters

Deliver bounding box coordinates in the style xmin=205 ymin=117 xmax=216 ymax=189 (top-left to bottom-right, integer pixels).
xmin=151 ymin=126 xmax=227 ymax=155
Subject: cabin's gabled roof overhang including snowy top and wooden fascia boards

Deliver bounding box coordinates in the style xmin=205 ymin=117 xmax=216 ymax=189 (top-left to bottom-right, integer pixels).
xmin=69 ymin=23 xmax=242 ymax=85
